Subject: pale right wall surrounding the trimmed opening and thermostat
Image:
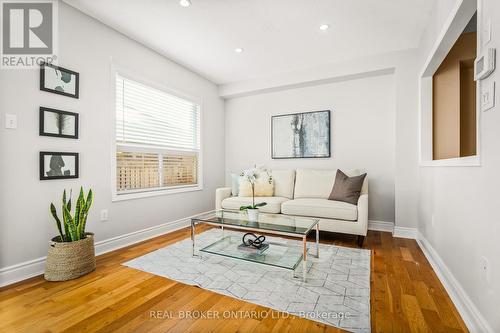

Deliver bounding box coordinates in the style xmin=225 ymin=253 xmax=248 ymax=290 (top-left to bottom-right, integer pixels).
xmin=418 ymin=0 xmax=500 ymax=332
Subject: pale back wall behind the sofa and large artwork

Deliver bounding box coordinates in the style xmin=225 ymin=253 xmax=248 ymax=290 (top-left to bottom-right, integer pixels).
xmin=225 ymin=74 xmax=396 ymax=222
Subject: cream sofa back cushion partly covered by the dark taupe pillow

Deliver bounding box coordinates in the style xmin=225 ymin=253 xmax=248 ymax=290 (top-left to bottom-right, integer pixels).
xmin=293 ymin=169 xmax=337 ymax=199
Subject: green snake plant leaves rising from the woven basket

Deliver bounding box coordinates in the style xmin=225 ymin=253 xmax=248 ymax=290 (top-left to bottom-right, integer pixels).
xmin=50 ymin=187 xmax=94 ymax=242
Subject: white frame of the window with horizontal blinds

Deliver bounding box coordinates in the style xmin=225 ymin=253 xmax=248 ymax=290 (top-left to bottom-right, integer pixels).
xmin=110 ymin=61 xmax=203 ymax=201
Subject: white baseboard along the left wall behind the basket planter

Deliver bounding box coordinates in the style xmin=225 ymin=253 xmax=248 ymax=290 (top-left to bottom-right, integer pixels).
xmin=0 ymin=212 xmax=208 ymax=287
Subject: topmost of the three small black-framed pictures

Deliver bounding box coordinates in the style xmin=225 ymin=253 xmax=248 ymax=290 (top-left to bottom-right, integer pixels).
xmin=40 ymin=63 xmax=80 ymax=98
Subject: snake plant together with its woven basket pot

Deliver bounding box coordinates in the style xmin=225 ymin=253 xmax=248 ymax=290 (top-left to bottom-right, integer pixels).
xmin=44 ymin=187 xmax=95 ymax=281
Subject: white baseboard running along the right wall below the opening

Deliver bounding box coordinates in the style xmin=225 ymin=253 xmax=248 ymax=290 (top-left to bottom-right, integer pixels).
xmin=417 ymin=232 xmax=493 ymax=333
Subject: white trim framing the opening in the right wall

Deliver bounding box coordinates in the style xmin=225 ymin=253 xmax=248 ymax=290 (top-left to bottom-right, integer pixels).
xmin=418 ymin=0 xmax=482 ymax=167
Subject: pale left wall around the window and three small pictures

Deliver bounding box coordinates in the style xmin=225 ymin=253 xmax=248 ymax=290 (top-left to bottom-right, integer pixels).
xmin=0 ymin=2 xmax=224 ymax=268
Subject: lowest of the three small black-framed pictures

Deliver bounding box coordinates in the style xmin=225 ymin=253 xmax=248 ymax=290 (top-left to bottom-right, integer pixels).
xmin=39 ymin=151 xmax=80 ymax=180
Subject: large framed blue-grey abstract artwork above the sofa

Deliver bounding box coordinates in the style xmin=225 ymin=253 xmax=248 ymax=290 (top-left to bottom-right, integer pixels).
xmin=271 ymin=110 xmax=330 ymax=159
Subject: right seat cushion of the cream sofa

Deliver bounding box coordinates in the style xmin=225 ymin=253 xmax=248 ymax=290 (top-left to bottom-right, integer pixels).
xmin=282 ymin=198 xmax=358 ymax=221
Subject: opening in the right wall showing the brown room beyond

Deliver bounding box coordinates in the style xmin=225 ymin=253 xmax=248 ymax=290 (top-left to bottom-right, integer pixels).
xmin=432 ymin=14 xmax=477 ymax=160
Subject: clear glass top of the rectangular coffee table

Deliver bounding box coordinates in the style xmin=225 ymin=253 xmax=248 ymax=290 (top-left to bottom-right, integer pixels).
xmin=192 ymin=210 xmax=319 ymax=235
